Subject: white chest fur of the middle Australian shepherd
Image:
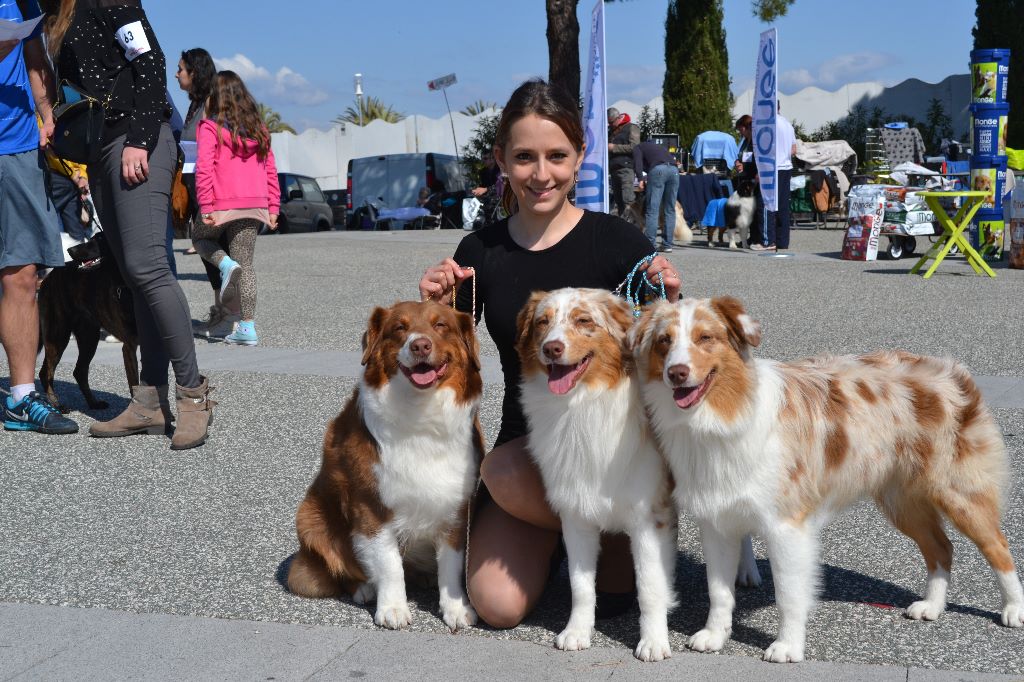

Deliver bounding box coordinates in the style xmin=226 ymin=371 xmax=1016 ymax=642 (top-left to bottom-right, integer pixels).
xmin=523 ymin=375 xmax=666 ymax=529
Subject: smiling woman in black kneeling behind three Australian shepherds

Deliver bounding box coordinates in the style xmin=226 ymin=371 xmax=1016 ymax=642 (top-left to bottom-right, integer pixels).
xmin=420 ymin=81 xmax=681 ymax=628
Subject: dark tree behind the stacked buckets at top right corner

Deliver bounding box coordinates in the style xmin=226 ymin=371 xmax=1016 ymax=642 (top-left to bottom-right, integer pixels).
xmin=965 ymin=0 xmax=1024 ymax=150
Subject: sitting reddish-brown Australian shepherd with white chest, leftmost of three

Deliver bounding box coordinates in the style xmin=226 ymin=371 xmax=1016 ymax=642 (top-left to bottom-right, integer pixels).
xmin=288 ymin=302 xmax=483 ymax=631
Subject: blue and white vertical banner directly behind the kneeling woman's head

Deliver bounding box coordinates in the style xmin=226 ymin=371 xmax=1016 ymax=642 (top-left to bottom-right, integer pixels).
xmin=575 ymin=0 xmax=608 ymax=213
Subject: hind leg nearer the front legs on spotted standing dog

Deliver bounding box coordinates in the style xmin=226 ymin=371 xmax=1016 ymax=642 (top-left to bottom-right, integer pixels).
xmin=878 ymin=489 xmax=953 ymax=621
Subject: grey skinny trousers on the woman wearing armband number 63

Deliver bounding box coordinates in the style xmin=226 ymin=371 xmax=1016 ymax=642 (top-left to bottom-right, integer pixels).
xmin=89 ymin=123 xmax=200 ymax=388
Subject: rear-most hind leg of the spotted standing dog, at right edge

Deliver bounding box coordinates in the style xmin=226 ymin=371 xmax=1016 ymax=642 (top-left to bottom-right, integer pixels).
xmin=936 ymin=486 xmax=1024 ymax=628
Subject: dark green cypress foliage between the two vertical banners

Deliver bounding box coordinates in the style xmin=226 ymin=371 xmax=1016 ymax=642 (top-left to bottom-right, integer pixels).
xmin=662 ymin=0 xmax=732 ymax=147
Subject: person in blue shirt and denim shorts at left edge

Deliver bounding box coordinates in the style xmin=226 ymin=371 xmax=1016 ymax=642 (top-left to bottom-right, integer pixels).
xmin=0 ymin=0 xmax=78 ymax=433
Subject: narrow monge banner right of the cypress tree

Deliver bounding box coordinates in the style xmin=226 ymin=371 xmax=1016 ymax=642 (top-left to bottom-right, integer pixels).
xmin=751 ymin=29 xmax=778 ymax=211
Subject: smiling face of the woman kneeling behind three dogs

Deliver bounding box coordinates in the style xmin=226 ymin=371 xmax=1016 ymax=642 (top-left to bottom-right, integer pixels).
xmin=496 ymin=114 xmax=583 ymax=215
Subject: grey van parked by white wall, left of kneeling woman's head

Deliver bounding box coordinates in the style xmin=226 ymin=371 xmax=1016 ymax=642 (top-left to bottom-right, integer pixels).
xmin=348 ymin=153 xmax=466 ymax=214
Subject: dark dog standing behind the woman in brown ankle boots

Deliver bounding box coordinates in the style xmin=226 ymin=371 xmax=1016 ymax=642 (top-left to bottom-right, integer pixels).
xmin=39 ymin=243 xmax=138 ymax=412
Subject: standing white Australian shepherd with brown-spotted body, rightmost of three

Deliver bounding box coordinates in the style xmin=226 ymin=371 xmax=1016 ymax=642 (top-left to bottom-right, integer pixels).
xmin=631 ymin=298 xmax=1024 ymax=662
